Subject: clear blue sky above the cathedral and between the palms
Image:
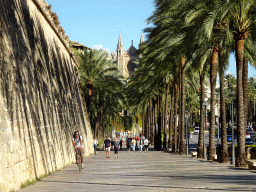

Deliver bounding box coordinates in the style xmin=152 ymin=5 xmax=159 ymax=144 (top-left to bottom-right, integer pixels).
xmin=46 ymin=0 xmax=256 ymax=78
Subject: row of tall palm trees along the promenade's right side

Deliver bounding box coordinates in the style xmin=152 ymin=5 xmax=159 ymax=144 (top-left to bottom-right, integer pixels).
xmin=127 ymin=0 xmax=256 ymax=167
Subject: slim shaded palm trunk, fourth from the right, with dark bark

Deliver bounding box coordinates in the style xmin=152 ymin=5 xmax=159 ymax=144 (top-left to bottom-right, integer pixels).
xmin=197 ymin=70 xmax=205 ymax=158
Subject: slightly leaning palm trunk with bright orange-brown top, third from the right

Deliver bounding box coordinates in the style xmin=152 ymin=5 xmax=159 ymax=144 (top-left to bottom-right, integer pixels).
xmin=208 ymin=47 xmax=218 ymax=160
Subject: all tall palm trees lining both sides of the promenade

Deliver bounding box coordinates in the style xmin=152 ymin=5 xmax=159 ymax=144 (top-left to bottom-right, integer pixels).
xmin=74 ymin=0 xmax=256 ymax=167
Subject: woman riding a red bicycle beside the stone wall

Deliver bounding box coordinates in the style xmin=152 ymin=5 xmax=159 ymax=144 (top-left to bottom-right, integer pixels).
xmin=72 ymin=131 xmax=84 ymax=169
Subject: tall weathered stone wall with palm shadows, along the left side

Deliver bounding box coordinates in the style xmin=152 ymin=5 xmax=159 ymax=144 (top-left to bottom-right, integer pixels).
xmin=0 ymin=0 xmax=93 ymax=192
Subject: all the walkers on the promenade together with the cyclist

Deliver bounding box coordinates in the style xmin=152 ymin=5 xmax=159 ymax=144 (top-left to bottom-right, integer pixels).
xmin=72 ymin=131 xmax=149 ymax=169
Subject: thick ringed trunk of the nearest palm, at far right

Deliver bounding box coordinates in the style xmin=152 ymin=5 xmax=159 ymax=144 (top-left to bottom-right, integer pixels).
xmin=235 ymin=38 xmax=246 ymax=167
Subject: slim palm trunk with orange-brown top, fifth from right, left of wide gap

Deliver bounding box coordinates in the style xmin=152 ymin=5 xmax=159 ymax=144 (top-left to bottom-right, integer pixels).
xmin=179 ymin=56 xmax=186 ymax=155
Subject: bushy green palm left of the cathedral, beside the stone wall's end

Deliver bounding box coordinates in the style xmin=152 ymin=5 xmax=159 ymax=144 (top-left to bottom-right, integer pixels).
xmin=76 ymin=49 xmax=124 ymax=137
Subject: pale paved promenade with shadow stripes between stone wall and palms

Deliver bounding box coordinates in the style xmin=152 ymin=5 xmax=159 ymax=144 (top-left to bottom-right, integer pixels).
xmin=19 ymin=146 xmax=256 ymax=192
